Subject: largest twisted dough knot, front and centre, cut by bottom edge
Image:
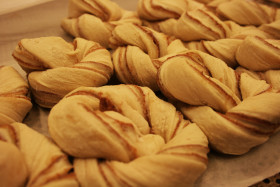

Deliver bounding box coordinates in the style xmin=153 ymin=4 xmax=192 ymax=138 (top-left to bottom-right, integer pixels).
xmin=48 ymin=85 xmax=208 ymax=186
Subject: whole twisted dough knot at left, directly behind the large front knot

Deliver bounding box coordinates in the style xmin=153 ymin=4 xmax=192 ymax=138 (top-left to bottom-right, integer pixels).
xmin=13 ymin=37 xmax=113 ymax=108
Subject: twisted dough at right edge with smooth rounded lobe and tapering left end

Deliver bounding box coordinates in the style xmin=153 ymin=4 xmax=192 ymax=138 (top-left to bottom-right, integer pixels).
xmin=184 ymin=36 xmax=280 ymax=68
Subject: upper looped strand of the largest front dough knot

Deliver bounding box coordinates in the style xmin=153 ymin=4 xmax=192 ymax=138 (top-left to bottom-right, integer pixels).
xmin=49 ymin=85 xmax=196 ymax=159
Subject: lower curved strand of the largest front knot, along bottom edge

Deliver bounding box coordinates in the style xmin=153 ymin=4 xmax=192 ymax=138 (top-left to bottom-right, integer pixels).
xmin=74 ymin=124 xmax=208 ymax=187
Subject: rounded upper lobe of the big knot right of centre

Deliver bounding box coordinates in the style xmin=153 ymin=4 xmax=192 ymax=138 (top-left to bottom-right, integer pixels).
xmin=158 ymin=50 xmax=241 ymax=111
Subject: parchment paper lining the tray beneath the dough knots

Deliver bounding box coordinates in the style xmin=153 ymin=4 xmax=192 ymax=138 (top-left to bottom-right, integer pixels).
xmin=0 ymin=0 xmax=280 ymax=187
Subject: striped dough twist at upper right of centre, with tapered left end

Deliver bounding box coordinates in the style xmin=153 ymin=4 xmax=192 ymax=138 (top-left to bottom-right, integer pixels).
xmin=144 ymin=8 xmax=231 ymax=41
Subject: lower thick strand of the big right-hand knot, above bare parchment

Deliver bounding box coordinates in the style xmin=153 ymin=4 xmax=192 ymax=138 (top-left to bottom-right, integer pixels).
xmin=181 ymin=93 xmax=280 ymax=155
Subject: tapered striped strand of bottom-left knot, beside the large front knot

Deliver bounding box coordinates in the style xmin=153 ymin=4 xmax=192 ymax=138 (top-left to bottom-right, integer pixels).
xmin=13 ymin=123 xmax=78 ymax=186
